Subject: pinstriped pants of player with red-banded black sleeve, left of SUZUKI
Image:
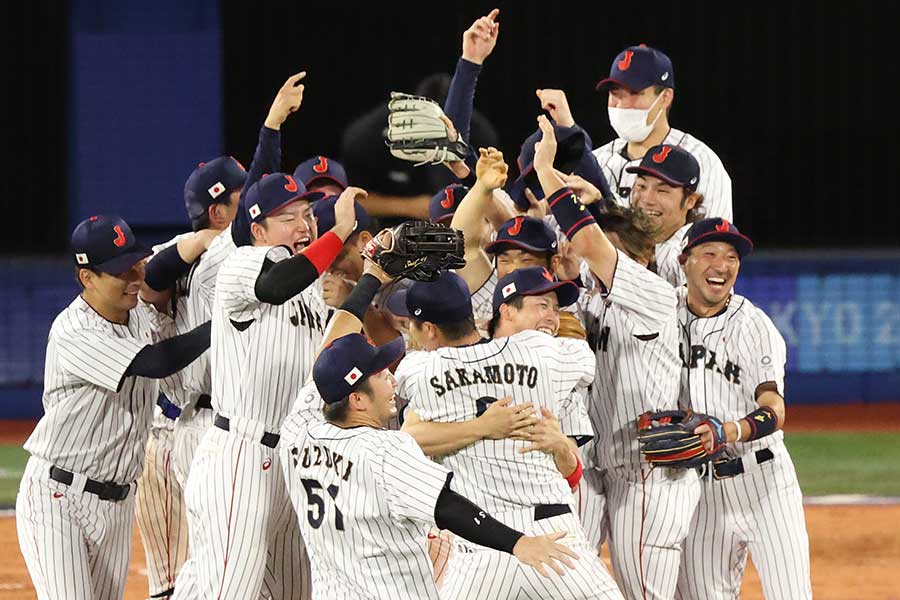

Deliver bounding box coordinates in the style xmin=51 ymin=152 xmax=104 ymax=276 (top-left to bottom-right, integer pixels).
xmin=175 ymin=418 xmax=311 ymax=600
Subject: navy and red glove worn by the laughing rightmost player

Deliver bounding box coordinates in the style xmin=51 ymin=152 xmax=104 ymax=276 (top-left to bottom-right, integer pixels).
xmin=638 ymin=410 xmax=725 ymax=469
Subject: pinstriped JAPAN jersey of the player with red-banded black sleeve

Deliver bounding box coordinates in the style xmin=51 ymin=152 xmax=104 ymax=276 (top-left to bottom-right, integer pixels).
xmin=212 ymin=246 xmax=328 ymax=432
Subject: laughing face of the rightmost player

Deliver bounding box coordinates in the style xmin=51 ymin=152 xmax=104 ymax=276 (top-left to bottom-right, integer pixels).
xmin=682 ymin=242 xmax=741 ymax=316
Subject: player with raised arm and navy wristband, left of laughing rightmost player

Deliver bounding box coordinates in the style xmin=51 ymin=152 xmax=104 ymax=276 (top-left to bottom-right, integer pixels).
xmin=534 ymin=115 xmax=700 ymax=599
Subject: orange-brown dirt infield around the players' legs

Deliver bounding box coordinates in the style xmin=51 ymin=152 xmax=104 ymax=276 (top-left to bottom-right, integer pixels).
xmin=0 ymin=506 xmax=900 ymax=600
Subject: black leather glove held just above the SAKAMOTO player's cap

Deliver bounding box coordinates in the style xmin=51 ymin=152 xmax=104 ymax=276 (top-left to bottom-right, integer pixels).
xmin=362 ymin=221 xmax=466 ymax=281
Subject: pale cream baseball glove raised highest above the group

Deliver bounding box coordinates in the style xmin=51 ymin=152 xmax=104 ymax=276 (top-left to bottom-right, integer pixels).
xmin=385 ymin=92 xmax=469 ymax=167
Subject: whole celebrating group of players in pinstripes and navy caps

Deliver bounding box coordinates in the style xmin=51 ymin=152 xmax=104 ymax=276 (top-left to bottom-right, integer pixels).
xmin=16 ymin=10 xmax=812 ymax=600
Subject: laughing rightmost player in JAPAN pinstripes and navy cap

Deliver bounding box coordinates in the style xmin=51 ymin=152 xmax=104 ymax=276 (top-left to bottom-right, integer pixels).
xmin=677 ymin=219 xmax=812 ymax=600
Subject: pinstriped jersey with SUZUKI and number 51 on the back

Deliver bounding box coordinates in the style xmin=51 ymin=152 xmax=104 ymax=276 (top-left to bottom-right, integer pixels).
xmin=280 ymin=384 xmax=449 ymax=600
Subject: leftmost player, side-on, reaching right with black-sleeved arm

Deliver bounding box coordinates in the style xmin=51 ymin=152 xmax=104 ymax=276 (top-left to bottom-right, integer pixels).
xmin=16 ymin=215 xmax=210 ymax=599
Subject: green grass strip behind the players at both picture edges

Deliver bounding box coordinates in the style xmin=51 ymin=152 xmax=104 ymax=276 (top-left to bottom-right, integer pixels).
xmin=0 ymin=433 xmax=900 ymax=506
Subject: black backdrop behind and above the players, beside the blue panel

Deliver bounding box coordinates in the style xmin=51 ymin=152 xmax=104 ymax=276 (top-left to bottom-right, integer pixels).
xmin=0 ymin=1 xmax=900 ymax=253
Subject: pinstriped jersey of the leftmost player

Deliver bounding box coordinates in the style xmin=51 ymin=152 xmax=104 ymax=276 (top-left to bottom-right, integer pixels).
xmin=25 ymin=296 xmax=173 ymax=483
